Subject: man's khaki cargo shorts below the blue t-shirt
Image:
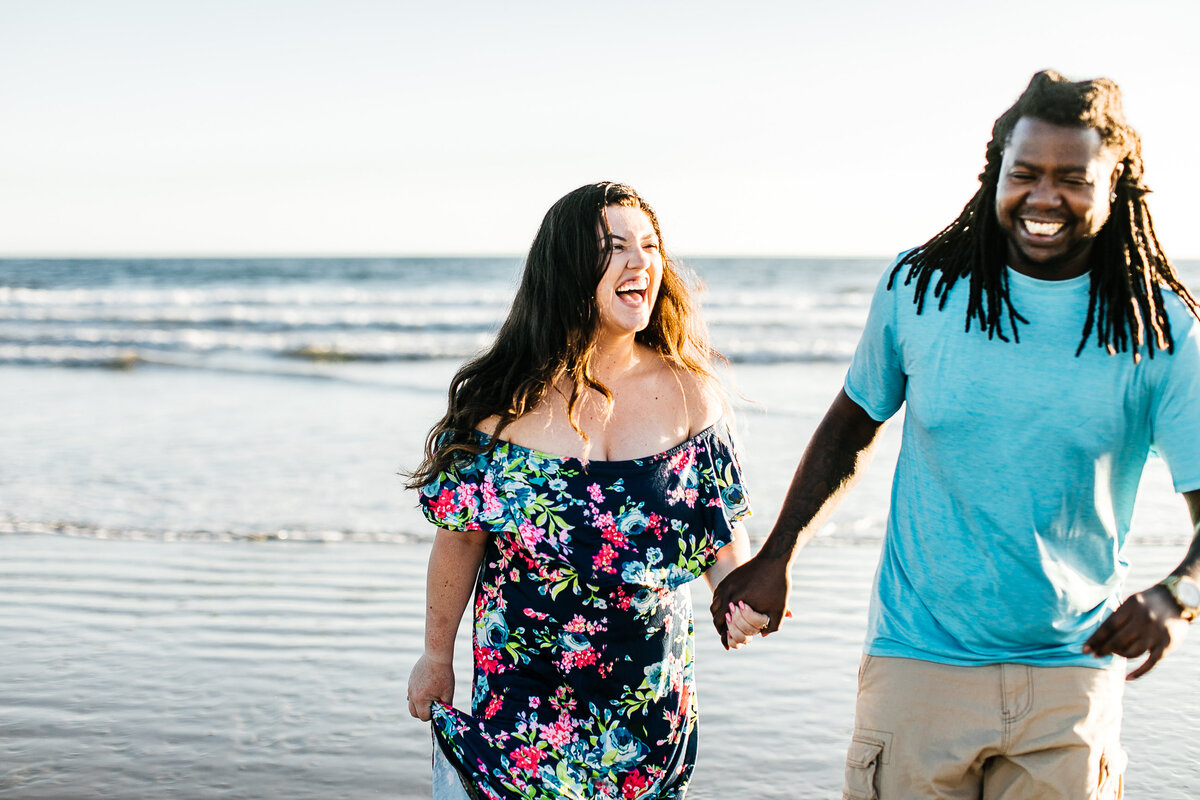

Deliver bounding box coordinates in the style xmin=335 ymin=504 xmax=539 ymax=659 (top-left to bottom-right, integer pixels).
xmin=842 ymin=656 xmax=1126 ymax=800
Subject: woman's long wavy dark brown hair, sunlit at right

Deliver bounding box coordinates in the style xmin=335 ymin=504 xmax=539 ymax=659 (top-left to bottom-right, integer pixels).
xmin=407 ymin=182 xmax=720 ymax=488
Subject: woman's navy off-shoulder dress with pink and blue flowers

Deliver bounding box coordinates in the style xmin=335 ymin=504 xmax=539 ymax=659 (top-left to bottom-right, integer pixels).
xmin=421 ymin=422 xmax=750 ymax=800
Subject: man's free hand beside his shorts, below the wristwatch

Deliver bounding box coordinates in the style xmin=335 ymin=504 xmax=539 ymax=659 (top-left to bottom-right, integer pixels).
xmin=1084 ymin=587 xmax=1188 ymax=680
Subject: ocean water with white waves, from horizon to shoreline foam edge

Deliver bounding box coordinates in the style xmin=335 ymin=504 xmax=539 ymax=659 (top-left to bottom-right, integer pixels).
xmin=0 ymin=258 xmax=1200 ymax=541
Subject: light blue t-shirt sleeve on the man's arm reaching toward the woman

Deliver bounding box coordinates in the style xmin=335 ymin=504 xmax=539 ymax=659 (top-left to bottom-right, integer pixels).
xmin=845 ymin=261 xmax=907 ymax=422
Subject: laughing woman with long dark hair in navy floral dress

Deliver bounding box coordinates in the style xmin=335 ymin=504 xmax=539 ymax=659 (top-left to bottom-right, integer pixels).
xmin=408 ymin=184 xmax=768 ymax=800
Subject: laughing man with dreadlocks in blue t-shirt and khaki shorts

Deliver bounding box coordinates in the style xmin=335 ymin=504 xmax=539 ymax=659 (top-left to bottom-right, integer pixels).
xmin=713 ymin=72 xmax=1200 ymax=800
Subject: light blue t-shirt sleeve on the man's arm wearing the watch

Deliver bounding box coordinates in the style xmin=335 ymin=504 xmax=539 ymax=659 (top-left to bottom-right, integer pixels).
xmin=1151 ymin=303 xmax=1200 ymax=492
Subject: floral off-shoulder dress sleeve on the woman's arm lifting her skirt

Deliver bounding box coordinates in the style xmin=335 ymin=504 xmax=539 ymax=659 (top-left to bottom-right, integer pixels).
xmin=419 ymin=455 xmax=505 ymax=533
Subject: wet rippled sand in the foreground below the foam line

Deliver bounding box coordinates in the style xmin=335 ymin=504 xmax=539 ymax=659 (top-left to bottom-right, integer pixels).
xmin=0 ymin=534 xmax=1200 ymax=800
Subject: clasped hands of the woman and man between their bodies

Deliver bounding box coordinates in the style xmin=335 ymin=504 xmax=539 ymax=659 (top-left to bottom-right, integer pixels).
xmin=709 ymin=557 xmax=792 ymax=650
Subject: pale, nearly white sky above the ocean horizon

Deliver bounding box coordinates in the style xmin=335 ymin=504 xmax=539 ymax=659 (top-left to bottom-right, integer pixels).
xmin=0 ymin=0 xmax=1200 ymax=259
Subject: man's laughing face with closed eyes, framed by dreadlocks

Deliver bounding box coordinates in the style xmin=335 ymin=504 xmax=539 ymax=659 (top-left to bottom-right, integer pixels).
xmin=996 ymin=116 xmax=1121 ymax=281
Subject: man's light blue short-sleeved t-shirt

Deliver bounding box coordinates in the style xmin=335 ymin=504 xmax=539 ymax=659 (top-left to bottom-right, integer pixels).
xmin=845 ymin=257 xmax=1200 ymax=667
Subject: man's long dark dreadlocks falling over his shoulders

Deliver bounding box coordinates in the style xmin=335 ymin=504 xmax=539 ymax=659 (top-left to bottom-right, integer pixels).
xmin=888 ymin=71 xmax=1200 ymax=361
